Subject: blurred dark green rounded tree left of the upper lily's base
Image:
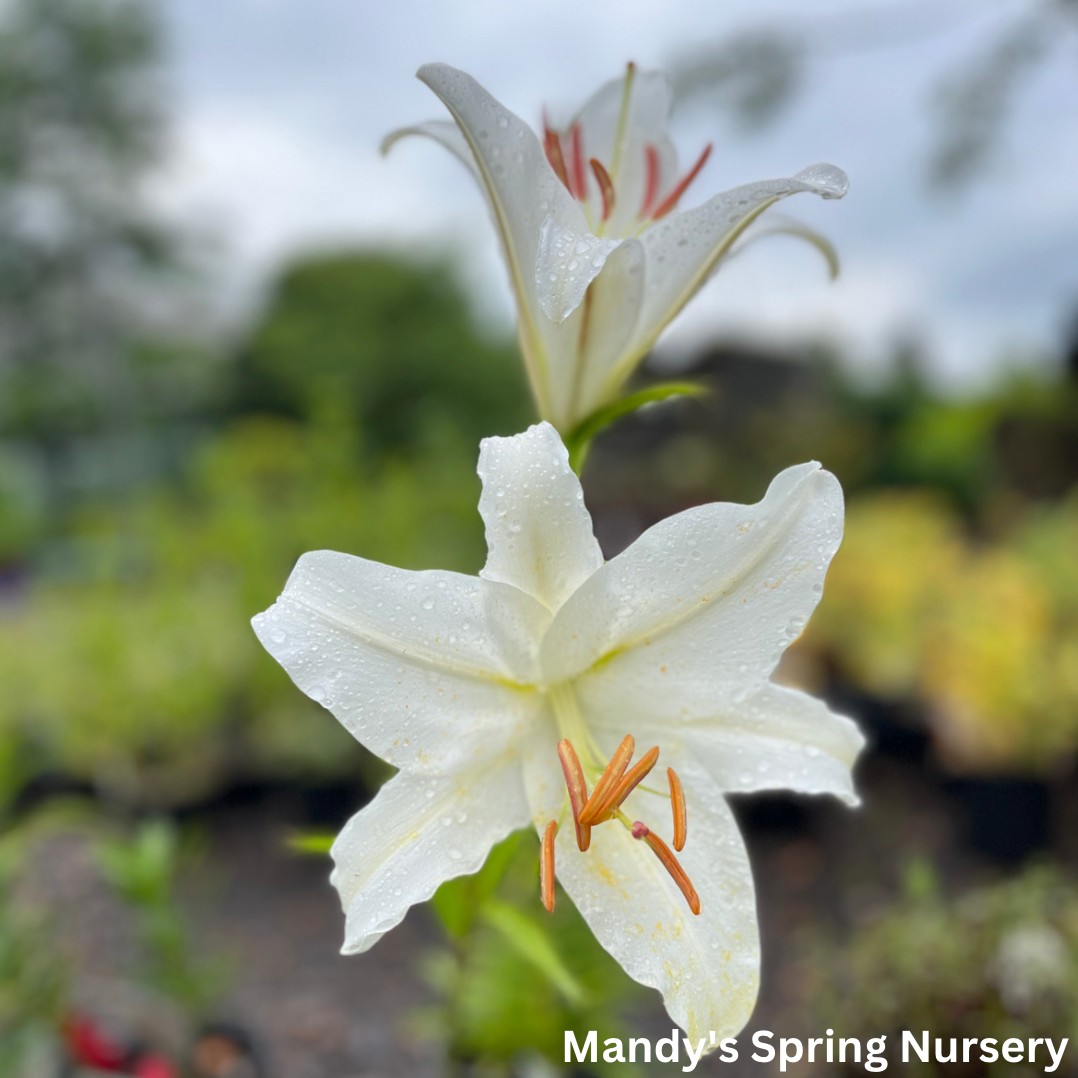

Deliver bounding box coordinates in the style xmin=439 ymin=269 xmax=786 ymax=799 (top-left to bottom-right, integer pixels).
xmin=235 ymin=253 xmax=531 ymax=452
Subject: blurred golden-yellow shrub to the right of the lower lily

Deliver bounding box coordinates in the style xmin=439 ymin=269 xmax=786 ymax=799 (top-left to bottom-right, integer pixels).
xmin=802 ymin=490 xmax=1078 ymax=771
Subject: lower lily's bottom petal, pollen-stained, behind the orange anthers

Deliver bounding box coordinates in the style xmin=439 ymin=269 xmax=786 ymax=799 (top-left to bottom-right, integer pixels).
xmin=525 ymin=745 xmax=760 ymax=1044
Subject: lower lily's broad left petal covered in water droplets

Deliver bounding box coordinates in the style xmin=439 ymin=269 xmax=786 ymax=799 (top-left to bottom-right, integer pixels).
xmin=252 ymin=551 xmax=550 ymax=773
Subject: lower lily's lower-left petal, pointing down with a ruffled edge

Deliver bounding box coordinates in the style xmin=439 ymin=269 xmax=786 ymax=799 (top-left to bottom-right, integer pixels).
xmin=330 ymin=760 xmax=529 ymax=954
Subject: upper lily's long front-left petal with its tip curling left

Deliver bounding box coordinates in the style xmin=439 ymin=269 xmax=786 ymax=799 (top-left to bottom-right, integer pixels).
xmin=418 ymin=64 xmax=588 ymax=418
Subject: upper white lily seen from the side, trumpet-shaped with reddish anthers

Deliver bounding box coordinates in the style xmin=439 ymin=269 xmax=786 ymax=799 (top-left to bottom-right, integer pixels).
xmin=383 ymin=64 xmax=848 ymax=434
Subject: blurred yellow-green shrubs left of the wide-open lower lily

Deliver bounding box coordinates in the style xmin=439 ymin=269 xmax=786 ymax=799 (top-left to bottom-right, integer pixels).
xmin=0 ymin=418 xmax=482 ymax=803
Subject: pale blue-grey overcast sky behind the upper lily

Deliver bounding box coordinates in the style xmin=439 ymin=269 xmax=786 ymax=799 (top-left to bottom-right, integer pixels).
xmin=160 ymin=0 xmax=1078 ymax=384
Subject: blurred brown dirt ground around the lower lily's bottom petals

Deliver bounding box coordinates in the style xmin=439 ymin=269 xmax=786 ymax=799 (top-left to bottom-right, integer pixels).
xmin=18 ymin=737 xmax=1026 ymax=1078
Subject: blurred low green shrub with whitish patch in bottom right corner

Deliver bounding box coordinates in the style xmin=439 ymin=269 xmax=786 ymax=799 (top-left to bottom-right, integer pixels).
xmin=802 ymin=865 xmax=1078 ymax=1076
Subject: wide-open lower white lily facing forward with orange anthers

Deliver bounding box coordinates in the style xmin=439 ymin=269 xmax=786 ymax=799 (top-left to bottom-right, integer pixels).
xmin=253 ymin=423 xmax=862 ymax=1039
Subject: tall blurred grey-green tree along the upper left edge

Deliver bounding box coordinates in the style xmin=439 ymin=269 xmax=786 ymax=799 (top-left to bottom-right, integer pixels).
xmin=0 ymin=0 xmax=218 ymax=517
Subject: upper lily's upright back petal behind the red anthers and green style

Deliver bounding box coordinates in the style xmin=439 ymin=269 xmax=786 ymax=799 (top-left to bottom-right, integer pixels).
xmin=576 ymin=71 xmax=677 ymax=236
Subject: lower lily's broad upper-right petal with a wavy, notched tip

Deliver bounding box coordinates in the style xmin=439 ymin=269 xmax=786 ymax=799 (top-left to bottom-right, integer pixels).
xmin=541 ymin=462 xmax=843 ymax=681
